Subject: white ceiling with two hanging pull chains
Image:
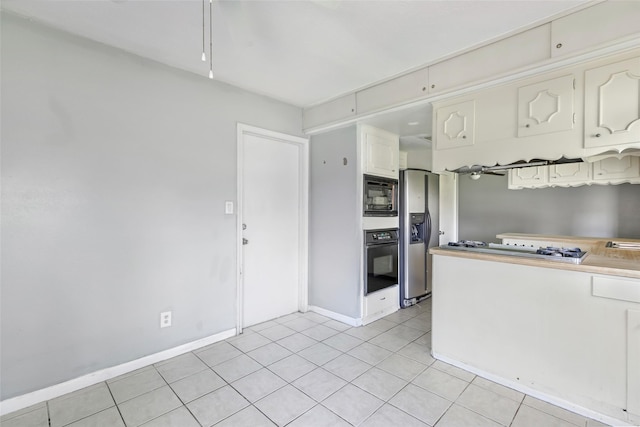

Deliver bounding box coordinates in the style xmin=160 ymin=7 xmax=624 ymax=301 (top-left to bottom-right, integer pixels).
xmin=2 ymin=0 xmax=586 ymax=111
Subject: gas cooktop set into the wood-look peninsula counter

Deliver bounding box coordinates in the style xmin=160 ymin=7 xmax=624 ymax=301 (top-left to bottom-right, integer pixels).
xmin=440 ymin=240 xmax=587 ymax=264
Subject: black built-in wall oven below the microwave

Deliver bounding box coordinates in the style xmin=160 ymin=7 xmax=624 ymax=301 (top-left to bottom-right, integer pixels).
xmin=364 ymin=228 xmax=398 ymax=295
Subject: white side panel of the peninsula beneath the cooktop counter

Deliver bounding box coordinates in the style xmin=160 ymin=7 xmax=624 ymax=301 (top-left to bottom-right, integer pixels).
xmin=432 ymin=255 xmax=640 ymax=420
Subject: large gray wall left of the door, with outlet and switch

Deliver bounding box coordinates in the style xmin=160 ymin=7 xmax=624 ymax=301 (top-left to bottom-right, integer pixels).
xmin=0 ymin=12 xmax=302 ymax=399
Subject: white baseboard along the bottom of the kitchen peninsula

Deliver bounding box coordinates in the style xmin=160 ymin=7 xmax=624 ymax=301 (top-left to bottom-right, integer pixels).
xmin=431 ymin=352 xmax=632 ymax=426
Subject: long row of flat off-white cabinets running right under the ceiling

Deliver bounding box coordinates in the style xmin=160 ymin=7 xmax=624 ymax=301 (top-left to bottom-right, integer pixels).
xmin=303 ymin=0 xmax=640 ymax=135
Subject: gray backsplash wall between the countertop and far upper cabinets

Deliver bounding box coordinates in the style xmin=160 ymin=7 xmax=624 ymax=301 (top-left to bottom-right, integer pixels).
xmin=459 ymin=175 xmax=640 ymax=242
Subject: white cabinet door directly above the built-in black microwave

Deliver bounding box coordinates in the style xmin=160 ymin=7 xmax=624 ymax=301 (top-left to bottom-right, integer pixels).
xmin=363 ymin=131 xmax=400 ymax=178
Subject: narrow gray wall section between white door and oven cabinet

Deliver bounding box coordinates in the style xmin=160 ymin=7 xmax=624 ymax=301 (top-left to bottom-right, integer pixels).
xmin=309 ymin=126 xmax=362 ymax=318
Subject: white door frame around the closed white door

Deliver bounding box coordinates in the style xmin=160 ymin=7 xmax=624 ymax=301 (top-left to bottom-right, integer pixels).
xmin=236 ymin=122 xmax=309 ymax=334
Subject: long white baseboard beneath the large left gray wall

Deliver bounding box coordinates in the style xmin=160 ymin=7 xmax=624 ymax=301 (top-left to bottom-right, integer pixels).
xmin=0 ymin=328 xmax=236 ymax=415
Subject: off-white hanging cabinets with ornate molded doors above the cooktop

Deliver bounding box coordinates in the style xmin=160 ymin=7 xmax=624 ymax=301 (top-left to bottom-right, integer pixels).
xmin=433 ymin=49 xmax=640 ymax=172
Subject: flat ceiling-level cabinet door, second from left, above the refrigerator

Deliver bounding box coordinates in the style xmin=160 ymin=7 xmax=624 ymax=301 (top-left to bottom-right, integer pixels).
xmin=356 ymin=68 xmax=429 ymax=114
